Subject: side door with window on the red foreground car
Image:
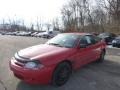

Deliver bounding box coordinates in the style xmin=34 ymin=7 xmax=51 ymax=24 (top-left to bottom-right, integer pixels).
xmin=76 ymin=36 xmax=93 ymax=68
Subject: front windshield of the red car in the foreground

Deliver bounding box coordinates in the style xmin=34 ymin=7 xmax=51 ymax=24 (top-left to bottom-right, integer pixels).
xmin=46 ymin=34 xmax=80 ymax=48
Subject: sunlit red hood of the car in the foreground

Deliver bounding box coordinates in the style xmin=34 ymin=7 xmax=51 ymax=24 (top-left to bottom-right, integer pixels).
xmin=18 ymin=44 xmax=69 ymax=59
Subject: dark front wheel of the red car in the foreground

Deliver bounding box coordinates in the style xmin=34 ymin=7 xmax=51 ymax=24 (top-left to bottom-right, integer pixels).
xmin=52 ymin=62 xmax=72 ymax=86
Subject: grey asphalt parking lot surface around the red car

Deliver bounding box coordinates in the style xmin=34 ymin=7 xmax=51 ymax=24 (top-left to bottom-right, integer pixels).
xmin=0 ymin=35 xmax=120 ymax=90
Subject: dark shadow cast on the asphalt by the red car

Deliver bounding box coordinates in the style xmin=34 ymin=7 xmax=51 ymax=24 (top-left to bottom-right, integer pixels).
xmin=16 ymin=60 xmax=120 ymax=90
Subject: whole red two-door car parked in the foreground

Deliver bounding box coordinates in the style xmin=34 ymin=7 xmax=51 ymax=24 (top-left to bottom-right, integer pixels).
xmin=10 ymin=33 xmax=106 ymax=86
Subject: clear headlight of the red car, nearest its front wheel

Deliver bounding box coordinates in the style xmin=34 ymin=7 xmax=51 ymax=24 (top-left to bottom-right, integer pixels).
xmin=24 ymin=61 xmax=43 ymax=69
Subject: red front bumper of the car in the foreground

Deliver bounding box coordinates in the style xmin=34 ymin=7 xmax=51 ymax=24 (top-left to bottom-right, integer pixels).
xmin=9 ymin=58 xmax=53 ymax=84
